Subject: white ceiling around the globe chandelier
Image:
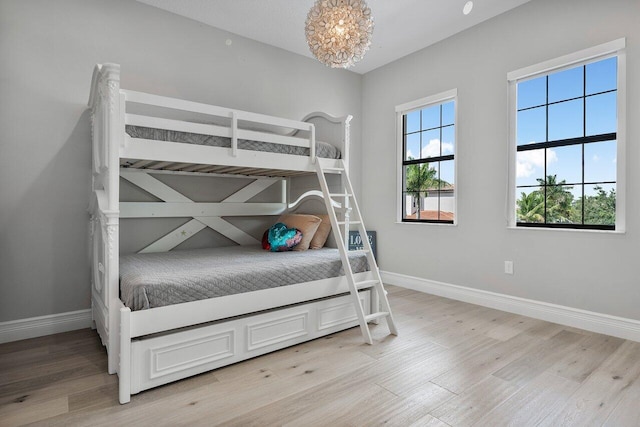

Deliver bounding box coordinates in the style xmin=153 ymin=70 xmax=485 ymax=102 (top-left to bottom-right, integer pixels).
xmin=138 ymin=0 xmax=530 ymax=74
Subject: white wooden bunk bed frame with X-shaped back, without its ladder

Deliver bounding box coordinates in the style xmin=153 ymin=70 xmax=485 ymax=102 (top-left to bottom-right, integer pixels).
xmin=89 ymin=64 xmax=378 ymax=403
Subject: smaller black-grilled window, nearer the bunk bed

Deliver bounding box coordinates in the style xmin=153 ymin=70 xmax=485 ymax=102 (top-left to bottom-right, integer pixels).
xmin=396 ymin=90 xmax=456 ymax=224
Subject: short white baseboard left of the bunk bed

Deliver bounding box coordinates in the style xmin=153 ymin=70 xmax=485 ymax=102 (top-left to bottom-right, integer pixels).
xmin=0 ymin=309 xmax=91 ymax=344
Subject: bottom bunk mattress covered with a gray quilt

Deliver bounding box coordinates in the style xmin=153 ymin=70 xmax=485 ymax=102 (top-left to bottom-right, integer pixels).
xmin=120 ymin=246 xmax=369 ymax=310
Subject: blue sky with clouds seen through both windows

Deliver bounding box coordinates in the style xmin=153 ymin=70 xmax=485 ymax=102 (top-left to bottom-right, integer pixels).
xmin=406 ymin=57 xmax=617 ymax=198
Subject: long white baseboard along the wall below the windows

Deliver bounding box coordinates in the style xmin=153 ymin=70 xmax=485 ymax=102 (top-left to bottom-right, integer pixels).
xmin=380 ymin=271 xmax=640 ymax=341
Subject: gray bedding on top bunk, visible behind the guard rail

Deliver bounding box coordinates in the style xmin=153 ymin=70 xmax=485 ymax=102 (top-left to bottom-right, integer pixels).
xmin=126 ymin=125 xmax=341 ymax=159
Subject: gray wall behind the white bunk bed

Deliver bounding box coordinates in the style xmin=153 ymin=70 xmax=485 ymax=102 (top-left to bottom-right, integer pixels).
xmin=0 ymin=0 xmax=362 ymax=322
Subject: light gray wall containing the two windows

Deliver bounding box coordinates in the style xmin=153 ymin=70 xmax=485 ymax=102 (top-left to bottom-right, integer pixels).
xmin=362 ymin=0 xmax=640 ymax=319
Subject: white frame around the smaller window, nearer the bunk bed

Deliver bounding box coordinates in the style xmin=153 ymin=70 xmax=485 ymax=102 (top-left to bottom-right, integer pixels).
xmin=396 ymin=89 xmax=458 ymax=225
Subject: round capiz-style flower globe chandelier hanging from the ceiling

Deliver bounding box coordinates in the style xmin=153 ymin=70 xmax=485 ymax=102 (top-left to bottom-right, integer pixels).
xmin=305 ymin=0 xmax=373 ymax=68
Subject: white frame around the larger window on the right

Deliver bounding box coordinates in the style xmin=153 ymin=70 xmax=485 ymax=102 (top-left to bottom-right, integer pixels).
xmin=506 ymin=38 xmax=627 ymax=233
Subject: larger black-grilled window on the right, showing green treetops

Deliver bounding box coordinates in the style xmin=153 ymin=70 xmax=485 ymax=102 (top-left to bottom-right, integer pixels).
xmin=510 ymin=39 xmax=622 ymax=230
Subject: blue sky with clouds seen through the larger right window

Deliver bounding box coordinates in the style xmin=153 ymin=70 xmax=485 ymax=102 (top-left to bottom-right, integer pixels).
xmin=516 ymin=57 xmax=617 ymax=201
